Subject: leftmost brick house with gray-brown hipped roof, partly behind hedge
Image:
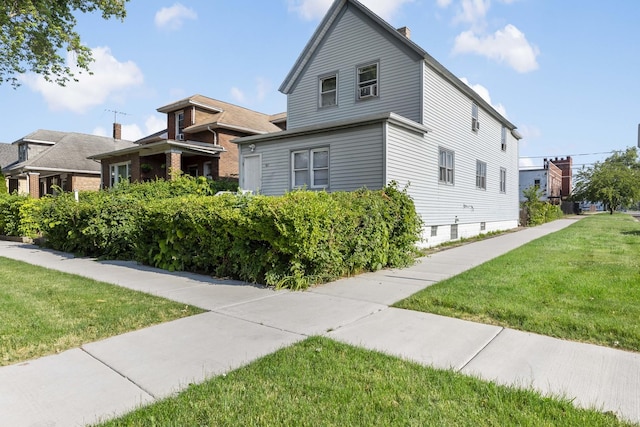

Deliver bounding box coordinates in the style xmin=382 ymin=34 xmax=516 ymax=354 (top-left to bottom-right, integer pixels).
xmin=2 ymin=129 xmax=135 ymax=198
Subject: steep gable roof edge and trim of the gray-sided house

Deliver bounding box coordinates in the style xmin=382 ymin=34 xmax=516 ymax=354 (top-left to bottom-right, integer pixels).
xmin=278 ymin=0 xmax=521 ymax=132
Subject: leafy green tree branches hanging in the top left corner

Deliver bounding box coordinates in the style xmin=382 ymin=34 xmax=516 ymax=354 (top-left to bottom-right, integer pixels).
xmin=0 ymin=0 xmax=129 ymax=88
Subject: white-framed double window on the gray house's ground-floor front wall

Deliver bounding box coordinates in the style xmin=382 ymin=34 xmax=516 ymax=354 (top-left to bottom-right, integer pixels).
xmin=291 ymin=148 xmax=329 ymax=188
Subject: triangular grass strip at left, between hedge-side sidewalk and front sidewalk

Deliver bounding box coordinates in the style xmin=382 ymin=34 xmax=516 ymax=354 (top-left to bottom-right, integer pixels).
xmin=0 ymin=257 xmax=202 ymax=366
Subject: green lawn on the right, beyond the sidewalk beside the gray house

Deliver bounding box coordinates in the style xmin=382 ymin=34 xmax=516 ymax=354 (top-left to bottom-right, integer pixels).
xmin=395 ymin=214 xmax=640 ymax=351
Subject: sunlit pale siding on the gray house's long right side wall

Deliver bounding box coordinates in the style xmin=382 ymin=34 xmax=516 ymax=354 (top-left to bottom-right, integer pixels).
xmin=420 ymin=65 xmax=519 ymax=225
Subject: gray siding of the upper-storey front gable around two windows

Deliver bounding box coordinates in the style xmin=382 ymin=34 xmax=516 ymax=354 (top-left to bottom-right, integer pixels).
xmin=287 ymin=7 xmax=422 ymax=129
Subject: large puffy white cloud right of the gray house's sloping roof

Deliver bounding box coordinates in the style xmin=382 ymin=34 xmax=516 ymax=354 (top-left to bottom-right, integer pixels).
xmin=453 ymin=24 xmax=540 ymax=73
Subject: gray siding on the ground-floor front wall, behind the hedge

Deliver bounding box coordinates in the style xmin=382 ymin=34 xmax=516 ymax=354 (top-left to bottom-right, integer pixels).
xmin=241 ymin=124 xmax=384 ymax=195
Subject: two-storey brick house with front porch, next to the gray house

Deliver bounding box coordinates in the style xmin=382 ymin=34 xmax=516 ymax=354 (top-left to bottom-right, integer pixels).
xmin=92 ymin=95 xmax=286 ymax=187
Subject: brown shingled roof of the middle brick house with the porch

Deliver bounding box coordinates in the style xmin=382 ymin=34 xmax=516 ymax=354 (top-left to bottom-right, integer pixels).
xmin=157 ymin=94 xmax=281 ymax=134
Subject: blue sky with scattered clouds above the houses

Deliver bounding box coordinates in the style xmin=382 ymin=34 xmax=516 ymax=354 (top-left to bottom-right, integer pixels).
xmin=0 ymin=0 xmax=640 ymax=171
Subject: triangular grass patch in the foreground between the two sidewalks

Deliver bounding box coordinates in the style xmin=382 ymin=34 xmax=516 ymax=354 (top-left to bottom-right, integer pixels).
xmin=97 ymin=337 xmax=624 ymax=426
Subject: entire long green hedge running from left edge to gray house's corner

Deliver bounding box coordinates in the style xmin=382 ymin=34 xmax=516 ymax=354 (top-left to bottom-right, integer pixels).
xmin=0 ymin=177 xmax=422 ymax=289
